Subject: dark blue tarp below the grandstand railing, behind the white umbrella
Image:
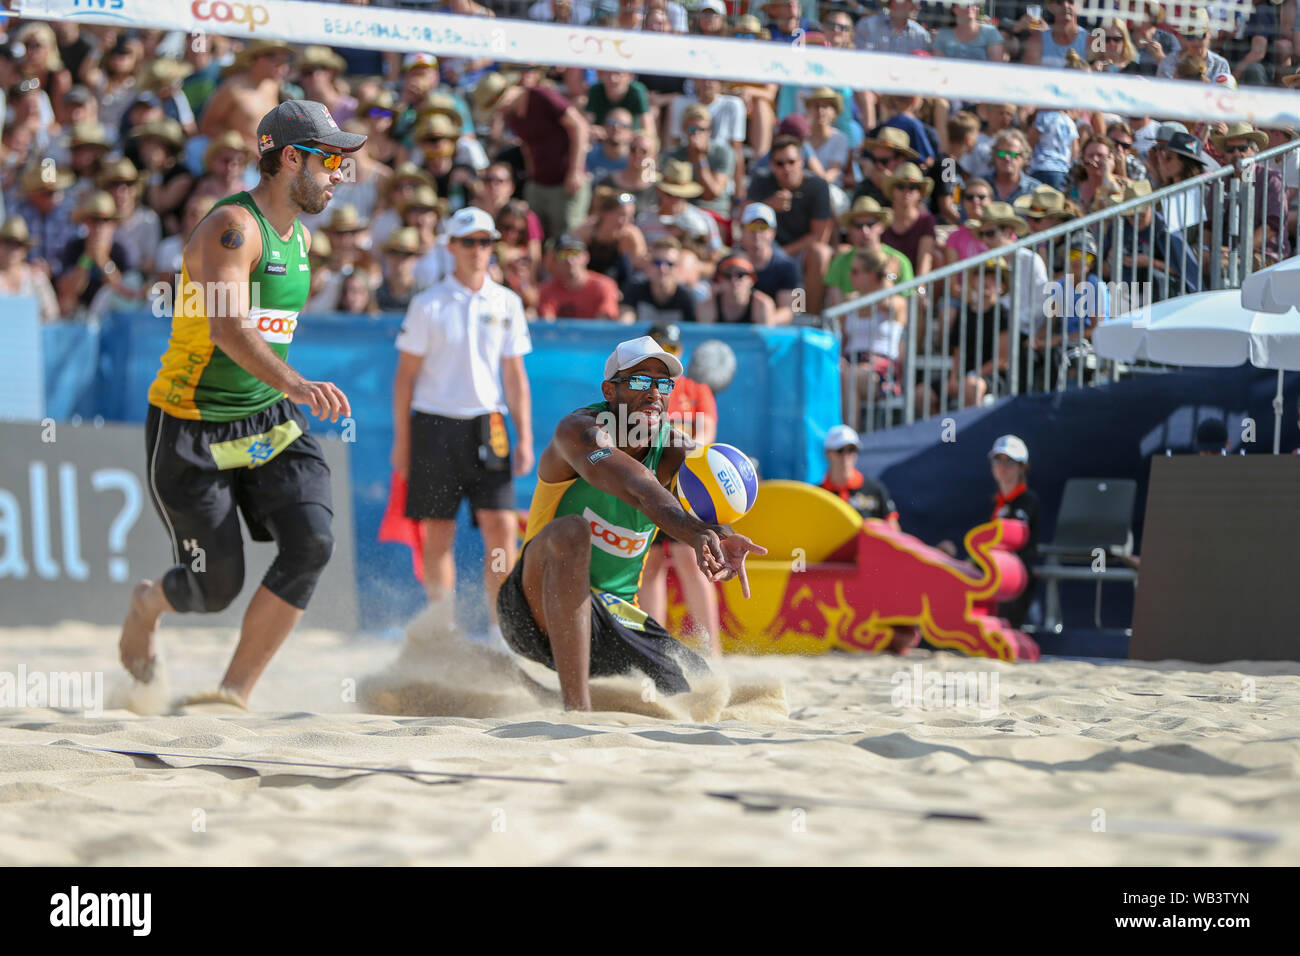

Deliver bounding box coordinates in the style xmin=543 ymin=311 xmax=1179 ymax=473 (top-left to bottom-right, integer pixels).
xmin=858 ymin=365 xmax=1300 ymax=627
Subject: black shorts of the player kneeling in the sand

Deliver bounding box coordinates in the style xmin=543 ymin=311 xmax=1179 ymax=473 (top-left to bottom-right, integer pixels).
xmin=497 ymin=545 xmax=709 ymax=693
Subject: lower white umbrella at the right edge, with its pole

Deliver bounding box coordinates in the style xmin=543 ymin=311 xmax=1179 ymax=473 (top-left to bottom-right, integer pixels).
xmin=1093 ymin=289 xmax=1300 ymax=454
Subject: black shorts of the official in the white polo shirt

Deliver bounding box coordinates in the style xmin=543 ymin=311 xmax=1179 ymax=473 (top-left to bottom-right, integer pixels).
xmin=406 ymin=411 xmax=515 ymax=520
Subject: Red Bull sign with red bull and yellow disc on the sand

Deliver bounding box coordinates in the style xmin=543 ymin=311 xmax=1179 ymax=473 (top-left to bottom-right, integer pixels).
xmin=664 ymin=481 xmax=1040 ymax=661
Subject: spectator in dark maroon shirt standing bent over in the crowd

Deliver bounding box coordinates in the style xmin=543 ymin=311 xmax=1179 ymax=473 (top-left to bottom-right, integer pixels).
xmin=473 ymin=65 xmax=592 ymax=237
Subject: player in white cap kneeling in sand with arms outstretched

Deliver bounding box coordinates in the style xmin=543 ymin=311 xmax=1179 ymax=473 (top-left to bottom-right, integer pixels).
xmin=497 ymin=336 xmax=767 ymax=710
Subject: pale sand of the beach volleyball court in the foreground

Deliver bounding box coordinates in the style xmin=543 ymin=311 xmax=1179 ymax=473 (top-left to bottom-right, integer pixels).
xmin=0 ymin=624 xmax=1300 ymax=865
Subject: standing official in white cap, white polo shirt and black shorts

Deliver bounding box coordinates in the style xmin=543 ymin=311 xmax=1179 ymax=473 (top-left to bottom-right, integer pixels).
xmin=393 ymin=207 xmax=533 ymax=648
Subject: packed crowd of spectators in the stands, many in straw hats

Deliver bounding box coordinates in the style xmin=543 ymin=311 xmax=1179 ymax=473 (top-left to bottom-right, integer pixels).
xmin=0 ymin=0 xmax=1300 ymax=395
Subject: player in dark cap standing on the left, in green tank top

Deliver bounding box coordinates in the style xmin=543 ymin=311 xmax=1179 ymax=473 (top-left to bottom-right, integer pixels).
xmin=120 ymin=100 xmax=365 ymax=705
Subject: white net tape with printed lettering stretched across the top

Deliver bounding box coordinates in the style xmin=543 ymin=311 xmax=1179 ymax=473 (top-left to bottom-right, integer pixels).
xmin=17 ymin=0 xmax=1300 ymax=126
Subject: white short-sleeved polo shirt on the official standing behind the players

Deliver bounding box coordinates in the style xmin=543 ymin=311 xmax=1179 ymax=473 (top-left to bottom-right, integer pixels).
xmin=397 ymin=276 xmax=533 ymax=419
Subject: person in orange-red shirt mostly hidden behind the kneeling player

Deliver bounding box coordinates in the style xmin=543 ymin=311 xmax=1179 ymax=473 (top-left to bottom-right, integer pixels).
xmin=637 ymin=323 xmax=722 ymax=654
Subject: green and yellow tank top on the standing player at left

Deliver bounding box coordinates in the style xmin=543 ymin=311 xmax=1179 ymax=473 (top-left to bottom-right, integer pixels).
xmin=150 ymin=193 xmax=312 ymax=421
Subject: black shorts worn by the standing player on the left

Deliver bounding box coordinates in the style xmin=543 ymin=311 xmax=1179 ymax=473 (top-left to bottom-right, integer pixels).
xmin=144 ymin=398 xmax=334 ymax=554
